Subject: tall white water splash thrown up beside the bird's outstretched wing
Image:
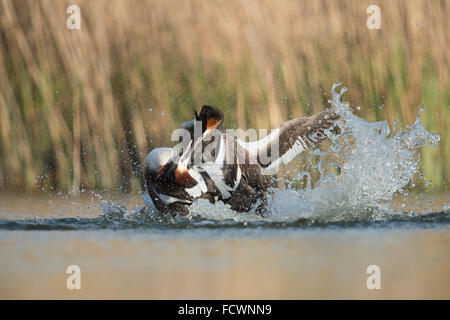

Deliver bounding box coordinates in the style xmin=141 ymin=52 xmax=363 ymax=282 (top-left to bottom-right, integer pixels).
xmin=190 ymin=84 xmax=439 ymax=222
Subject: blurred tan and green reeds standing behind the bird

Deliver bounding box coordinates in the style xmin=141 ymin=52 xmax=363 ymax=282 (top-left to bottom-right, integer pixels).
xmin=0 ymin=0 xmax=450 ymax=191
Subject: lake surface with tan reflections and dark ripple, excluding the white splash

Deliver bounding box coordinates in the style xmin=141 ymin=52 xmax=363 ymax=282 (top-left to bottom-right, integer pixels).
xmin=0 ymin=193 xmax=450 ymax=299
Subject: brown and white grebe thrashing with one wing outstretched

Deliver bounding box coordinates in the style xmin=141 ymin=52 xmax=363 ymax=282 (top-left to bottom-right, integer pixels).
xmin=144 ymin=106 xmax=338 ymax=214
